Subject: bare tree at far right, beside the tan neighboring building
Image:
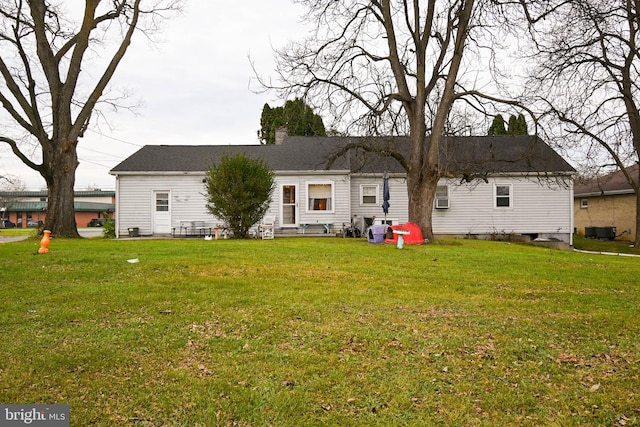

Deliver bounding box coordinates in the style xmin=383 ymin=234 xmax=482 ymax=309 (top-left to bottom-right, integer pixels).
xmin=522 ymin=0 xmax=640 ymax=247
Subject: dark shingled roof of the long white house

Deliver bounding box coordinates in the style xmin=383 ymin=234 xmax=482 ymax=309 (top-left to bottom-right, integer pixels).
xmin=110 ymin=136 xmax=575 ymax=176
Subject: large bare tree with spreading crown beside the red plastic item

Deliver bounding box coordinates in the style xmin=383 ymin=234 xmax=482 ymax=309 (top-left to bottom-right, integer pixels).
xmin=267 ymin=0 xmax=516 ymax=239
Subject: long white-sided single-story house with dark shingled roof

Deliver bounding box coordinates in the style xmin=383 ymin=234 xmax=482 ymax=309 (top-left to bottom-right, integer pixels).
xmin=110 ymin=136 xmax=575 ymax=244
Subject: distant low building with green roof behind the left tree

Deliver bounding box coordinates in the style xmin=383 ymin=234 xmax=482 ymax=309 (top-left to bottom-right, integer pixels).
xmin=0 ymin=190 xmax=116 ymax=228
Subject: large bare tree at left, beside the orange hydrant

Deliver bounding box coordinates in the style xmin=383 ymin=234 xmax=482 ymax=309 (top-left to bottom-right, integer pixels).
xmin=0 ymin=0 xmax=177 ymax=237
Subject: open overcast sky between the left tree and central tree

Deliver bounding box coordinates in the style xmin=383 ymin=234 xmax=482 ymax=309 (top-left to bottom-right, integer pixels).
xmin=0 ymin=0 xmax=306 ymax=190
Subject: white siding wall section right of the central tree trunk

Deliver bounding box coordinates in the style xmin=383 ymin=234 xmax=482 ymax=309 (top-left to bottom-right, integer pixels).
xmin=433 ymin=177 xmax=573 ymax=237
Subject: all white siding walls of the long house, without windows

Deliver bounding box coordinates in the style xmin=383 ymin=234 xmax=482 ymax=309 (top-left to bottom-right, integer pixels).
xmin=116 ymin=174 xmax=573 ymax=241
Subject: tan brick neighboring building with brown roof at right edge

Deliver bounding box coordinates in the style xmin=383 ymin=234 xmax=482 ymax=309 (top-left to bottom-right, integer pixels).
xmin=574 ymin=164 xmax=639 ymax=241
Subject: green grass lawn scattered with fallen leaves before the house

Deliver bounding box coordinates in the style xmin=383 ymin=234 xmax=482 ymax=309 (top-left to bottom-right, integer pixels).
xmin=0 ymin=238 xmax=640 ymax=426
